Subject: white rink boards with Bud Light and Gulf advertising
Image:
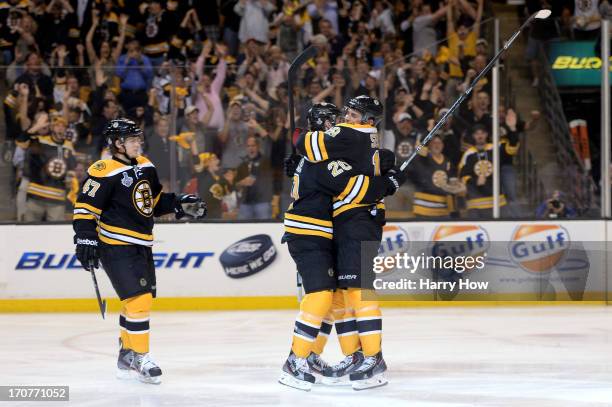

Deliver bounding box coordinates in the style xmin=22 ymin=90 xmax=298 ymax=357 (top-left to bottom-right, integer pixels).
xmin=0 ymin=221 xmax=612 ymax=312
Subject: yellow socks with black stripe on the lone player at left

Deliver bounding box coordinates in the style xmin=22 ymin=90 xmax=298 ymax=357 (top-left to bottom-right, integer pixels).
xmin=119 ymin=293 xmax=153 ymax=353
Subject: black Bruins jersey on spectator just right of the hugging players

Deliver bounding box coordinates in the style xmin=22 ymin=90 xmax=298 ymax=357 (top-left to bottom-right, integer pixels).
xmin=408 ymin=149 xmax=452 ymax=216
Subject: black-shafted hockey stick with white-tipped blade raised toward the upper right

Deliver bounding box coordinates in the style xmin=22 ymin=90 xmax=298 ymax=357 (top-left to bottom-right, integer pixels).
xmin=400 ymin=9 xmax=551 ymax=171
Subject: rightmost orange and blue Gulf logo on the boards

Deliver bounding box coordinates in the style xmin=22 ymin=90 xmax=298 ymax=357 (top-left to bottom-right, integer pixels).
xmin=508 ymin=225 xmax=570 ymax=273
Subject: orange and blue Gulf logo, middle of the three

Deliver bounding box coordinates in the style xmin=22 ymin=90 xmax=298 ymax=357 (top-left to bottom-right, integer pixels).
xmin=431 ymin=225 xmax=491 ymax=257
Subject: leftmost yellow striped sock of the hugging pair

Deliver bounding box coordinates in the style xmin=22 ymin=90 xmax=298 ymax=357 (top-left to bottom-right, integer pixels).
xmin=291 ymin=291 xmax=333 ymax=358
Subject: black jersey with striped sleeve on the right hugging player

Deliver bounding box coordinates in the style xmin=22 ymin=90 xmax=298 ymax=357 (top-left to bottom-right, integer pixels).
xmin=296 ymin=123 xmax=384 ymax=217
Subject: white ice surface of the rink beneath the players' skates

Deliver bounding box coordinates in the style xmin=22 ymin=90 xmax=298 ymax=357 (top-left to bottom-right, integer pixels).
xmin=0 ymin=306 xmax=612 ymax=407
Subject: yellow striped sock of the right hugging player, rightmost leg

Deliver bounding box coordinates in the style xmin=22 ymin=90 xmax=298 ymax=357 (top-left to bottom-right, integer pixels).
xmin=348 ymin=288 xmax=382 ymax=356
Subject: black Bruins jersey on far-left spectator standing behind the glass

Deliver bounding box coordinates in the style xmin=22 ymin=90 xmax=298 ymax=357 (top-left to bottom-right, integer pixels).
xmin=17 ymin=135 xmax=76 ymax=203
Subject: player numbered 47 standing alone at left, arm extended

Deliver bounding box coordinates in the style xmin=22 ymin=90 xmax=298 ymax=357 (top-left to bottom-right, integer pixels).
xmin=73 ymin=119 xmax=206 ymax=384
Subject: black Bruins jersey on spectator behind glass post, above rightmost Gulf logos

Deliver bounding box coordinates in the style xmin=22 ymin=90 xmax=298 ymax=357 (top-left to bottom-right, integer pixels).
xmin=459 ymin=132 xmax=519 ymax=209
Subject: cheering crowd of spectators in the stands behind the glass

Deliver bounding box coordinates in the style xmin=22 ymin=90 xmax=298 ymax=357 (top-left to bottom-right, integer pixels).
xmin=0 ymin=0 xmax=580 ymax=220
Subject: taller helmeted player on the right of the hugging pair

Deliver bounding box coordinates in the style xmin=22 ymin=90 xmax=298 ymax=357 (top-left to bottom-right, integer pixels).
xmin=298 ymin=96 xmax=406 ymax=390
